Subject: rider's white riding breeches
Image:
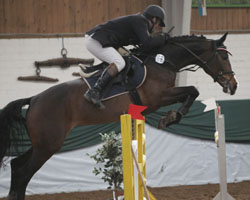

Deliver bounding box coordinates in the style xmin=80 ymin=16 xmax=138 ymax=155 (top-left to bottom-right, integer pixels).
xmin=85 ymin=35 xmax=126 ymax=72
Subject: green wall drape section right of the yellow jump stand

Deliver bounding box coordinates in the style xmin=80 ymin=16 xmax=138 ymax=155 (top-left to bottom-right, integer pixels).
xmin=147 ymin=100 xmax=250 ymax=142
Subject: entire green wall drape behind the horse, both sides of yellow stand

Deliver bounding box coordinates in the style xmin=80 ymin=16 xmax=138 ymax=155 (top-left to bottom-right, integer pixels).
xmin=1 ymin=100 xmax=250 ymax=155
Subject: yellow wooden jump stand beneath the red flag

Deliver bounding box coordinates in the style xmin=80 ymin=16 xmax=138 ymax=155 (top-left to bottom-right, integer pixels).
xmin=121 ymin=114 xmax=156 ymax=200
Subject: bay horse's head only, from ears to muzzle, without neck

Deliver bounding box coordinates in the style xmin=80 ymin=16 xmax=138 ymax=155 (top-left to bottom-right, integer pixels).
xmin=200 ymin=33 xmax=238 ymax=95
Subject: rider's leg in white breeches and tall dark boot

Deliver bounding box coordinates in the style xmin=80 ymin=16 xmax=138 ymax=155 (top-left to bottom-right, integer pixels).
xmin=84 ymin=36 xmax=125 ymax=108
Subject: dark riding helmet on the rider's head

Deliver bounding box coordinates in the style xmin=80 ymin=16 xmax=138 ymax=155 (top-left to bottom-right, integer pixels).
xmin=143 ymin=5 xmax=166 ymax=27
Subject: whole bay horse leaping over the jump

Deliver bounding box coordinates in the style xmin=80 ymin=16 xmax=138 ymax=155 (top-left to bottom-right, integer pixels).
xmin=0 ymin=34 xmax=237 ymax=200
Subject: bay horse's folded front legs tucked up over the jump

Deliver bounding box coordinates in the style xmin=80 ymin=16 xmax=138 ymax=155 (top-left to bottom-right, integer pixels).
xmin=158 ymin=86 xmax=199 ymax=129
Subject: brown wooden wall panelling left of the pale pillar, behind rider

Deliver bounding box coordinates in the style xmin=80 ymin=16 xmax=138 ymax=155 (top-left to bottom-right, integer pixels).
xmin=0 ymin=0 xmax=161 ymax=34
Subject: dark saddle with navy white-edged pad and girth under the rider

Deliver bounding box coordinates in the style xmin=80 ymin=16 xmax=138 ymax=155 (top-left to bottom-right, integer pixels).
xmin=80 ymin=55 xmax=146 ymax=105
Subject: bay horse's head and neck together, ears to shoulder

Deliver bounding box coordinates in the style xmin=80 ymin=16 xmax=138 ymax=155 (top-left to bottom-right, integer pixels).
xmin=142 ymin=33 xmax=238 ymax=95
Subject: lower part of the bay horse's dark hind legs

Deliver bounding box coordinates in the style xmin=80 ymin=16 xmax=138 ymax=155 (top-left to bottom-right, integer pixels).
xmin=8 ymin=149 xmax=53 ymax=200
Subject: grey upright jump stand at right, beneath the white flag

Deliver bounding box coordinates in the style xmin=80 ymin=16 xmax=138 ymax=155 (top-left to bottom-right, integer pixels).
xmin=213 ymin=105 xmax=235 ymax=200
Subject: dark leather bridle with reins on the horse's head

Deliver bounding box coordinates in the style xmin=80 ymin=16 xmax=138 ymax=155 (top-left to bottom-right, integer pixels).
xmin=172 ymin=43 xmax=235 ymax=88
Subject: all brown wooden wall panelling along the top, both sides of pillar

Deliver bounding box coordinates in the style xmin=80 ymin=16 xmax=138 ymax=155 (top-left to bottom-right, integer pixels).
xmin=0 ymin=0 xmax=250 ymax=37
